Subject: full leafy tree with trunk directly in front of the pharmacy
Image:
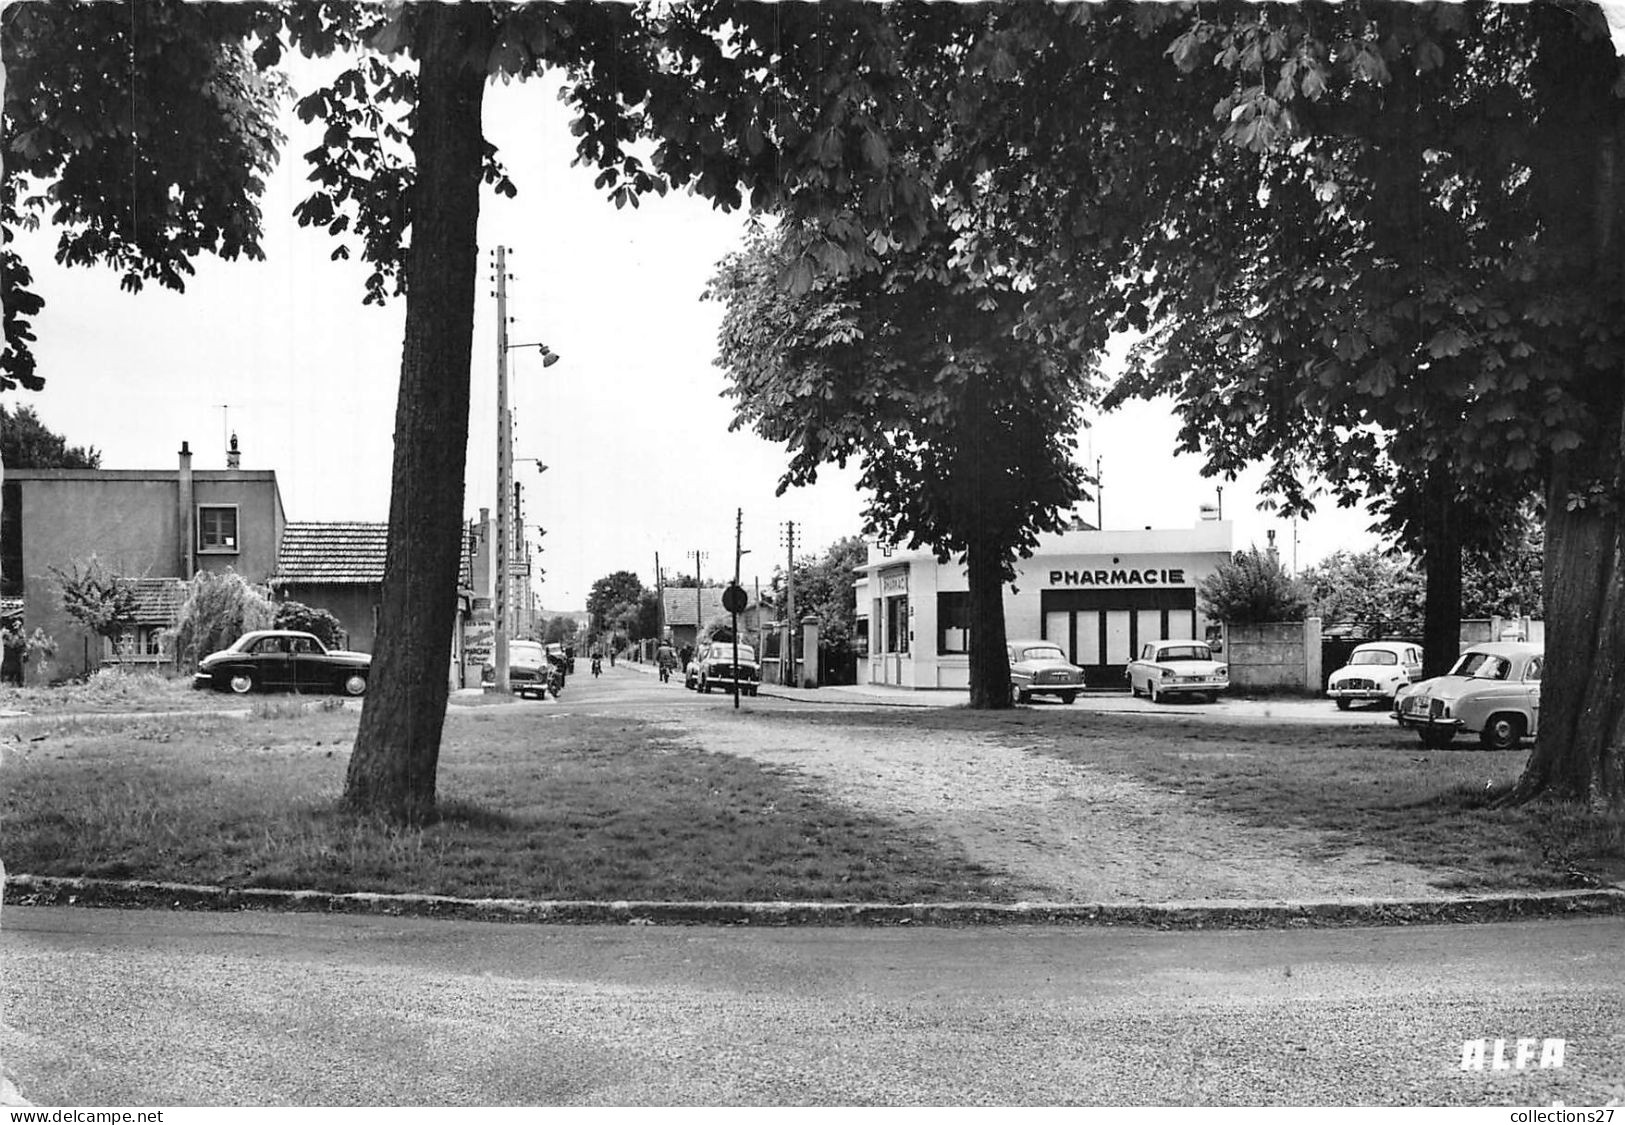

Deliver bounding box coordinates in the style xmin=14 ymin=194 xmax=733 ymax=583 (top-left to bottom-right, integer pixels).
xmin=709 ymin=226 xmax=1092 ymax=706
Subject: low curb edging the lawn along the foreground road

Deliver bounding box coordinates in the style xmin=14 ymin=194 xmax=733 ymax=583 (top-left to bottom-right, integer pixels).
xmin=5 ymin=875 xmax=1625 ymax=930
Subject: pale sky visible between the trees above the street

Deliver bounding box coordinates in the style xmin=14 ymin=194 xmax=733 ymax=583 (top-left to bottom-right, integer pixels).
xmin=0 ymin=59 xmax=1376 ymax=611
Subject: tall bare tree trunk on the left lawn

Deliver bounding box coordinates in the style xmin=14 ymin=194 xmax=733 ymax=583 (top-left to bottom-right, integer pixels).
xmin=345 ymin=3 xmax=491 ymax=823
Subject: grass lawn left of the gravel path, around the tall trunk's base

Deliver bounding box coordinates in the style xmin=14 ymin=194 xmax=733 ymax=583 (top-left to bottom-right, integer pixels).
xmin=0 ymin=697 xmax=1003 ymax=902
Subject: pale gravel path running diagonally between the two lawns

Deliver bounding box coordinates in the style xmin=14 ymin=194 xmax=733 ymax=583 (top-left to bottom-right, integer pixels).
xmin=681 ymin=714 xmax=1462 ymax=902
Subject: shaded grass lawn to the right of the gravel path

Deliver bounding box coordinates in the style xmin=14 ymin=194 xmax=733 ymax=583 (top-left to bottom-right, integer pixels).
xmin=760 ymin=707 xmax=1625 ymax=891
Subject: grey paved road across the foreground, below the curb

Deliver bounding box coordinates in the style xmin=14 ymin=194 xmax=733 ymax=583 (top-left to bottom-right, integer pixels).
xmin=0 ymin=907 xmax=1625 ymax=1105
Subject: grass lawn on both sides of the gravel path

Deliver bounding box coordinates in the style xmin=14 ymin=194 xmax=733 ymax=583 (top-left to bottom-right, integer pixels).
xmin=0 ymin=689 xmax=1625 ymax=902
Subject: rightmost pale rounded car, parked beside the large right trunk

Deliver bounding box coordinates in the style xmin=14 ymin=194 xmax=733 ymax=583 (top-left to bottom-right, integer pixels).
xmin=1394 ymin=641 xmax=1545 ymax=749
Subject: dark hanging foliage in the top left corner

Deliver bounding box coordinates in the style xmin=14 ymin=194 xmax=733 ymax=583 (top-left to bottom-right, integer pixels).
xmin=0 ymin=0 xmax=284 ymax=390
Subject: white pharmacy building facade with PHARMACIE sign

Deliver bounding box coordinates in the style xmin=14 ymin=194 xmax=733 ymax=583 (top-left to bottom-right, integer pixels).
xmin=856 ymin=520 xmax=1232 ymax=691
